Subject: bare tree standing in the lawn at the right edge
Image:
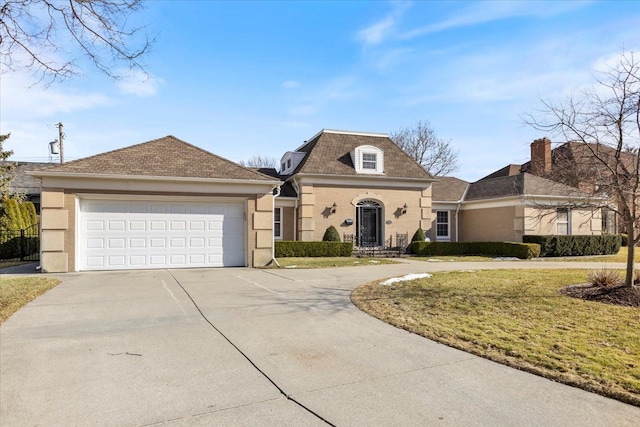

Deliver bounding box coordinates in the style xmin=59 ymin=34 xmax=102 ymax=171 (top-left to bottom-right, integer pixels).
xmin=525 ymin=52 xmax=640 ymax=287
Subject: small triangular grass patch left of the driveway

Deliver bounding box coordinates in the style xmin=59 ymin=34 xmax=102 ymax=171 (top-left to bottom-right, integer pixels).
xmin=0 ymin=276 xmax=60 ymax=324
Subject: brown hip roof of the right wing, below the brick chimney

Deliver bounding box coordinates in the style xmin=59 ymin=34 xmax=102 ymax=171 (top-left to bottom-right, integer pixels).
xmin=465 ymin=173 xmax=586 ymax=201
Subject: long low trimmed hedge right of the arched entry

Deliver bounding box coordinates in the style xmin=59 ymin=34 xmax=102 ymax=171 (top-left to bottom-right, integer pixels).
xmin=411 ymin=242 xmax=540 ymax=259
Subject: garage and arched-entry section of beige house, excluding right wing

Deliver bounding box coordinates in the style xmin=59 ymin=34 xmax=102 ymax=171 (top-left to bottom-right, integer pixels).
xmin=31 ymin=130 xmax=434 ymax=272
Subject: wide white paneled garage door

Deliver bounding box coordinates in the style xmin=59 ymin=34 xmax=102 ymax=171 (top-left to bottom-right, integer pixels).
xmin=78 ymin=199 xmax=245 ymax=270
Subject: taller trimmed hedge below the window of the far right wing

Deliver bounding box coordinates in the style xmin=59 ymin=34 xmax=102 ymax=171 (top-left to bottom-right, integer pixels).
xmin=522 ymin=234 xmax=622 ymax=257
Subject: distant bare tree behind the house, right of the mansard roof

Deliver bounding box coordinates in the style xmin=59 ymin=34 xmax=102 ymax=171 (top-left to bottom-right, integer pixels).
xmin=389 ymin=121 xmax=458 ymax=176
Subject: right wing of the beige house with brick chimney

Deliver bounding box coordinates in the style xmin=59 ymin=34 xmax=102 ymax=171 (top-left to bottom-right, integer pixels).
xmin=430 ymin=140 xmax=610 ymax=242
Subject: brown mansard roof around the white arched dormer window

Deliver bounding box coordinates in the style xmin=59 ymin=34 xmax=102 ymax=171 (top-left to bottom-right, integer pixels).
xmin=293 ymin=131 xmax=432 ymax=180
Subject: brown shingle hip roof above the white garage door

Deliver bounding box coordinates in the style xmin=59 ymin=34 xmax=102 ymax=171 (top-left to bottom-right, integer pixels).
xmin=36 ymin=135 xmax=273 ymax=181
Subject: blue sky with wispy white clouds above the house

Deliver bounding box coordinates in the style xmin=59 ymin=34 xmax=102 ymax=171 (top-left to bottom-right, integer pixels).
xmin=0 ymin=1 xmax=640 ymax=181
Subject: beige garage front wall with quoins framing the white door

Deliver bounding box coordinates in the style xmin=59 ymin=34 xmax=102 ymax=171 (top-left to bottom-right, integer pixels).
xmin=41 ymin=177 xmax=274 ymax=273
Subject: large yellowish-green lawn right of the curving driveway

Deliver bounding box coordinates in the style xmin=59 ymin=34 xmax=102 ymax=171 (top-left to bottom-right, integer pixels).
xmin=352 ymin=270 xmax=640 ymax=406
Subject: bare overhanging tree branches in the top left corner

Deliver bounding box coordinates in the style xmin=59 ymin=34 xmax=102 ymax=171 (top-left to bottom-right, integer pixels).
xmin=0 ymin=0 xmax=153 ymax=82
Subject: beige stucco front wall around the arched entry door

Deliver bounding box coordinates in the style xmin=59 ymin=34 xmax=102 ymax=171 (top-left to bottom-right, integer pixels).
xmin=298 ymin=185 xmax=432 ymax=244
